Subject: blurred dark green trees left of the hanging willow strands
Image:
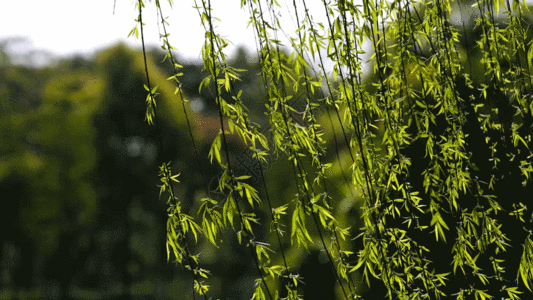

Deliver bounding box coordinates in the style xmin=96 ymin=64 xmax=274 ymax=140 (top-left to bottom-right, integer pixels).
xmin=0 ymin=45 xmax=218 ymax=299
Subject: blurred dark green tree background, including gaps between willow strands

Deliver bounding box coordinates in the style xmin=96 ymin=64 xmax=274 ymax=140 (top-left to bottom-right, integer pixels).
xmin=0 ymin=42 xmax=362 ymax=299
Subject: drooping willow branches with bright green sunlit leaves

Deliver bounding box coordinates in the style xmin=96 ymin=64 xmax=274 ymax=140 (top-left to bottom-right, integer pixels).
xmin=131 ymin=0 xmax=533 ymax=299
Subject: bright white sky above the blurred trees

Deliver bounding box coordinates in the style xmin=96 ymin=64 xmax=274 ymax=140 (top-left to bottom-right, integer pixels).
xmin=0 ymin=0 xmax=332 ymax=63
